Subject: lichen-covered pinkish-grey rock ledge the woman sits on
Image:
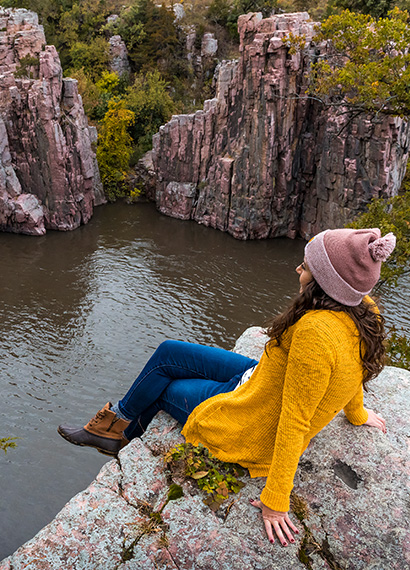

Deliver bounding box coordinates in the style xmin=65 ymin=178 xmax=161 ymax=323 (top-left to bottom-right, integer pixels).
xmin=0 ymin=327 xmax=410 ymax=570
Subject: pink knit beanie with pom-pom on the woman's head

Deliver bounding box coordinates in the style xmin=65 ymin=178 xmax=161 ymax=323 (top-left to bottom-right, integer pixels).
xmin=305 ymin=228 xmax=396 ymax=307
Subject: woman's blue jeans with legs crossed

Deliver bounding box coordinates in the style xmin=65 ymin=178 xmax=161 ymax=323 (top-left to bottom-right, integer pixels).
xmin=118 ymin=340 xmax=258 ymax=440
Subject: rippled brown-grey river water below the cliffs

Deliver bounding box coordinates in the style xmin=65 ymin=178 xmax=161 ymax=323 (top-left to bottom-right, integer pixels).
xmin=0 ymin=204 xmax=410 ymax=560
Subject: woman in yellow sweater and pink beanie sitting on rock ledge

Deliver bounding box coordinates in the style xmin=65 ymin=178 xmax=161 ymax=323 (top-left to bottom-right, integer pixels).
xmin=58 ymin=229 xmax=396 ymax=546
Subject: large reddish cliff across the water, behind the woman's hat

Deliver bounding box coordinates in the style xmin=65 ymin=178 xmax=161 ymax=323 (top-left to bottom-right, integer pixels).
xmin=153 ymin=13 xmax=409 ymax=239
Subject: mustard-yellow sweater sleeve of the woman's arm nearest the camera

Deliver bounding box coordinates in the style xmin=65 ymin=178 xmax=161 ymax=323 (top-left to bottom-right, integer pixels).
xmin=261 ymin=323 xmax=337 ymax=512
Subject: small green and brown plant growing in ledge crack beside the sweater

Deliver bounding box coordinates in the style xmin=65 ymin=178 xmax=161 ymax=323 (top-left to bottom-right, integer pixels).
xmin=164 ymin=443 xmax=244 ymax=512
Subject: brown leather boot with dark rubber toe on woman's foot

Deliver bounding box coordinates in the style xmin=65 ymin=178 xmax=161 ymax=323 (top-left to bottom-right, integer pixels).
xmin=57 ymin=402 xmax=131 ymax=456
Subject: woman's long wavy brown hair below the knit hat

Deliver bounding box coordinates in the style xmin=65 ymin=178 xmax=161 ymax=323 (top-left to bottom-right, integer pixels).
xmin=266 ymin=279 xmax=386 ymax=390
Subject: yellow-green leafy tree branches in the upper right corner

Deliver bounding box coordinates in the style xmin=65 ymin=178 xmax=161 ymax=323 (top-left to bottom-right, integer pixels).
xmin=309 ymin=8 xmax=410 ymax=117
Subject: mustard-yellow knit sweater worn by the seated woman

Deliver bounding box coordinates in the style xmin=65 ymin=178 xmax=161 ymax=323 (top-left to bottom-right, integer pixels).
xmin=182 ymin=310 xmax=368 ymax=511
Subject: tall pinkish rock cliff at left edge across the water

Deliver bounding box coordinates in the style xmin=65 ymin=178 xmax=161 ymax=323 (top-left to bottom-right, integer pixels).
xmin=0 ymin=8 xmax=105 ymax=235
